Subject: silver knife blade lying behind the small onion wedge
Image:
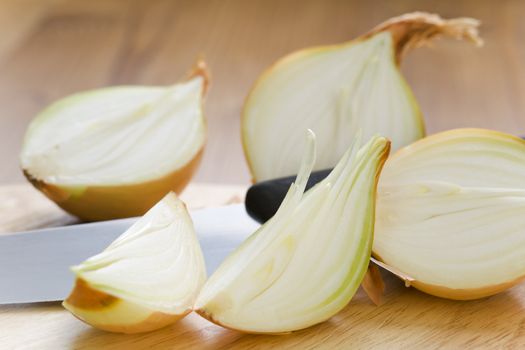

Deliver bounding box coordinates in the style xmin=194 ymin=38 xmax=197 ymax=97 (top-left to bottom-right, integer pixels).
xmin=0 ymin=204 xmax=259 ymax=304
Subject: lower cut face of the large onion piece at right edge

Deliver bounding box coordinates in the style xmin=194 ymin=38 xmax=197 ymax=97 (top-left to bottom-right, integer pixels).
xmin=374 ymin=182 xmax=525 ymax=289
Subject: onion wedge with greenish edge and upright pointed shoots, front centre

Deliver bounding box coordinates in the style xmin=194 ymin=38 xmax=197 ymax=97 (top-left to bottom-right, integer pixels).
xmin=195 ymin=133 xmax=390 ymax=333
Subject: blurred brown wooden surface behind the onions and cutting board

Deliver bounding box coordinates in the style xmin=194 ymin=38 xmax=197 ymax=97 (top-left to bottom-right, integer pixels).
xmin=0 ymin=0 xmax=525 ymax=183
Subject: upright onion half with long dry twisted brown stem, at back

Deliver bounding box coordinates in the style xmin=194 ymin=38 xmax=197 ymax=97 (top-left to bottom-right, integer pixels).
xmin=242 ymin=12 xmax=481 ymax=181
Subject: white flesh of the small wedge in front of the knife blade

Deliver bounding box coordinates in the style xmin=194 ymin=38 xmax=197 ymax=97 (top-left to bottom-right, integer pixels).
xmin=72 ymin=193 xmax=206 ymax=315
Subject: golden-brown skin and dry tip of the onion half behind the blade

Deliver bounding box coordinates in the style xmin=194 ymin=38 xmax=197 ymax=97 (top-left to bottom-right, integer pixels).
xmin=22 ymin=59 xmax=211 ymax=221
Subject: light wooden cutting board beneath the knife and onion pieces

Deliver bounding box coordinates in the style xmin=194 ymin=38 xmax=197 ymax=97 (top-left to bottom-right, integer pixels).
xmin=0 ymin=185 xmax=525 ymax=350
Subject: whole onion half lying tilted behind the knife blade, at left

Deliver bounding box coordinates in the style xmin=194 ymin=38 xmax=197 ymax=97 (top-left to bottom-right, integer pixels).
xmin=20 ymin=61 xmax=208 ymax=220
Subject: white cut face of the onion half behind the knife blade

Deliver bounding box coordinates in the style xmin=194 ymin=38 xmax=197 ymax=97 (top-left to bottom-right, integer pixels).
xmin=20 ymin=76 xmax=206 ymax=186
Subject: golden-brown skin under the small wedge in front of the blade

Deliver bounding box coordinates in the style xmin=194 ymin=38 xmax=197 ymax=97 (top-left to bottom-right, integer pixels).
xmin=62 ymin=278 xmax=191 ymax=334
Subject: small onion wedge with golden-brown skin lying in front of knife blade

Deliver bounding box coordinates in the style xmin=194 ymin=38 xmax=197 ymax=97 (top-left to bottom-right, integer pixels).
xmin=63 ymin=193 xmax=206 ymax=333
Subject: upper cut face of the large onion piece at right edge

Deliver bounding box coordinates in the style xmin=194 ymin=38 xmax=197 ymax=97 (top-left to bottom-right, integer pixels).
xmin=379 ymin=129 xmax=525 ymax=189
